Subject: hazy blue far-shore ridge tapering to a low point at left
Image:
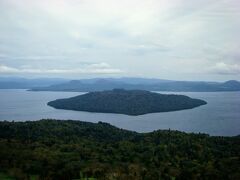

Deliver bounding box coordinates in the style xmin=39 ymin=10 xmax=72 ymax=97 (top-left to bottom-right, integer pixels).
xmin=31 ymin=78 xmax=240 ymax=92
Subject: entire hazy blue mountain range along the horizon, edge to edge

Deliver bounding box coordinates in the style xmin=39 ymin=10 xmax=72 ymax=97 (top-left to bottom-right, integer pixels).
xmin=0 ymin=77 xmax=240 ymax=92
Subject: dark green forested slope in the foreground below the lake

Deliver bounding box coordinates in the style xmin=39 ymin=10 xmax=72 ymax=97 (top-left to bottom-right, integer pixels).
xmin=0 ymin=120 xmax=240 ymax=180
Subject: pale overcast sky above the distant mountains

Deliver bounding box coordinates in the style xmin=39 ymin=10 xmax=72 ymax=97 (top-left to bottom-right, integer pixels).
xmin=0 ymin=0 xmax=240 ymax=81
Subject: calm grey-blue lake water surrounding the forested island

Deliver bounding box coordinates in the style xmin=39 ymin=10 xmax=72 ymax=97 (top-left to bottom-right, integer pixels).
xmin=0 ymin=89 xmax=240 ymax=136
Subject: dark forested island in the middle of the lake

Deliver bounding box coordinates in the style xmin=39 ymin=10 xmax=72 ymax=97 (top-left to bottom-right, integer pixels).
xmin=48 ymin=89 xmax=206 ymax=115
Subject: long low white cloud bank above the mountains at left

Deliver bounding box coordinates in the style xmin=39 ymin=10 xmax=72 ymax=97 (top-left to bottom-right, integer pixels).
xmin=0 ymin=63 xmax=123 ymax=74
